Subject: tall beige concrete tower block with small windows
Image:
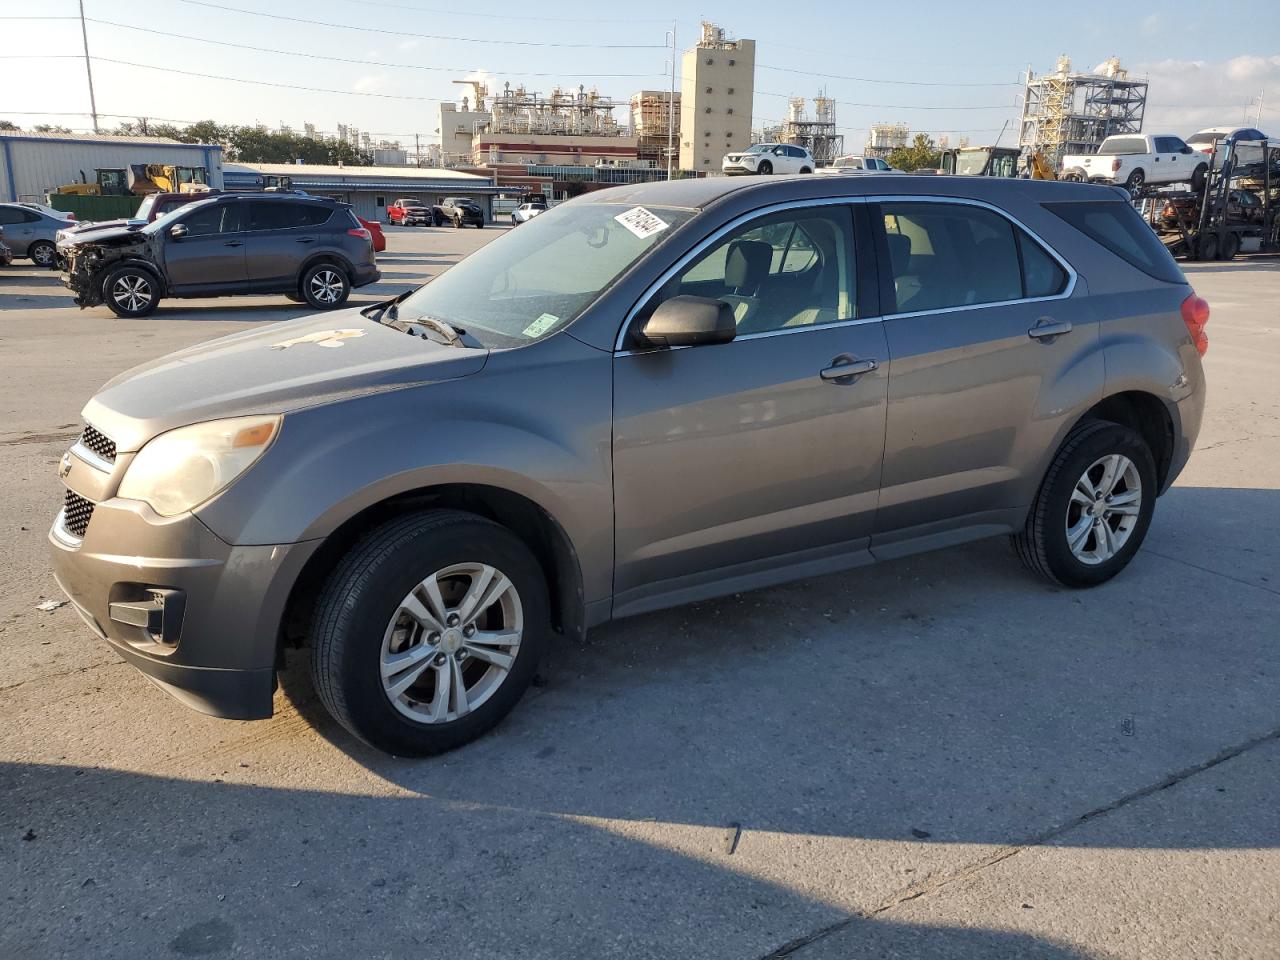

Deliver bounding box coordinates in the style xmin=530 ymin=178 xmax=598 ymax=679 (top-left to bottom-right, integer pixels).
xmin=680 ymin=22 xmax=755 ymax=173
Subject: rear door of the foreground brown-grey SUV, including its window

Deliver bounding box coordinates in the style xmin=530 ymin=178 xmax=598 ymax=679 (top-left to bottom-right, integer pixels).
xmin=869 ymin=198 xmax=1103 ymax=556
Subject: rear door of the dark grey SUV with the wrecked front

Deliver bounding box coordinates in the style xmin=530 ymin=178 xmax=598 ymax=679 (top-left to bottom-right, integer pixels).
xmin=246 ymin=200 xmax=337 ymax=291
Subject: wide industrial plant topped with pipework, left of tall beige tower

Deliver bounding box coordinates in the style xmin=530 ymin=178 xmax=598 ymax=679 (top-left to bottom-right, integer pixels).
xmin=440 ymin=81 xmax=639 ymax=166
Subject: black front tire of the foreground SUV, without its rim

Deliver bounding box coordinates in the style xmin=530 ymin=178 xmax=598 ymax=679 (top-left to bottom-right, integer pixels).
xmin=311 ymin=509 xmax=550 ymax=756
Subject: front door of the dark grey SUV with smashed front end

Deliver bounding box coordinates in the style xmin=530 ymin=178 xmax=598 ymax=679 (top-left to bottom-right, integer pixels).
xmin=164 ymin=202 xmax=246 ymax=296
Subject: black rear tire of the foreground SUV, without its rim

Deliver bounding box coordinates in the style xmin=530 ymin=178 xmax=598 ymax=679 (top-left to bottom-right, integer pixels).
xmin=1010 ymin=420 xmax=1156 ymax=588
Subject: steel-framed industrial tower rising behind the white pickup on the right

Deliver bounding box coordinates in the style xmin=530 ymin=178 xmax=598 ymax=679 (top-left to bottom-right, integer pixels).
xmin=1018 ymin=56 xmax=1147 ymax=168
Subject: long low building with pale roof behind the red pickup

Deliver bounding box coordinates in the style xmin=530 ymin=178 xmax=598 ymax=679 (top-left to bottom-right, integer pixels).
xmin=223 ymin=163 xmax=500 ymax=220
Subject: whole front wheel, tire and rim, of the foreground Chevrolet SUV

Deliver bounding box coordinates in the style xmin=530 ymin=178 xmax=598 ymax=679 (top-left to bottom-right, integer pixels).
xmin=311 ymin=511 xmax=550 ymax=756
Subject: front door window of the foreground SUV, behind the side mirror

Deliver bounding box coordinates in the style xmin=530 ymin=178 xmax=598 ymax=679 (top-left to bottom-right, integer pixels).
xmin=645 ymin=206 xmax=856 ymax=335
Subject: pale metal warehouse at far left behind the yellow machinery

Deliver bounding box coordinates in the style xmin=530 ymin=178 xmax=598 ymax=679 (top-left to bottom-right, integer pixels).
xmin=0 ymin=131 xmax=223 ymax=202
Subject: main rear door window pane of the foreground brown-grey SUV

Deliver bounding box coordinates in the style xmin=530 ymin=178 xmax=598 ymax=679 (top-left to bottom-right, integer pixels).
xmin=881 ymin=204 xmax=1023 ymax=312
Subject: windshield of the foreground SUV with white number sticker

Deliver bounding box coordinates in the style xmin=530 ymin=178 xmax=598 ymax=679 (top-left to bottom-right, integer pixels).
xmin=398 ymin=204 xmax=692 ymax=348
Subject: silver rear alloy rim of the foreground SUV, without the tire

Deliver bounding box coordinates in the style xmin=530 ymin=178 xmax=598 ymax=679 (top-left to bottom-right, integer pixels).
xmin=1066 ymin=453 xmax=1142 ymax=567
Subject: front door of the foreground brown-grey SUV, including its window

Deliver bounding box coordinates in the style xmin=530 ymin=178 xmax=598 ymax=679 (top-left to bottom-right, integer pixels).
xmin=613 ymin=204 xmax=888 ymax=613
